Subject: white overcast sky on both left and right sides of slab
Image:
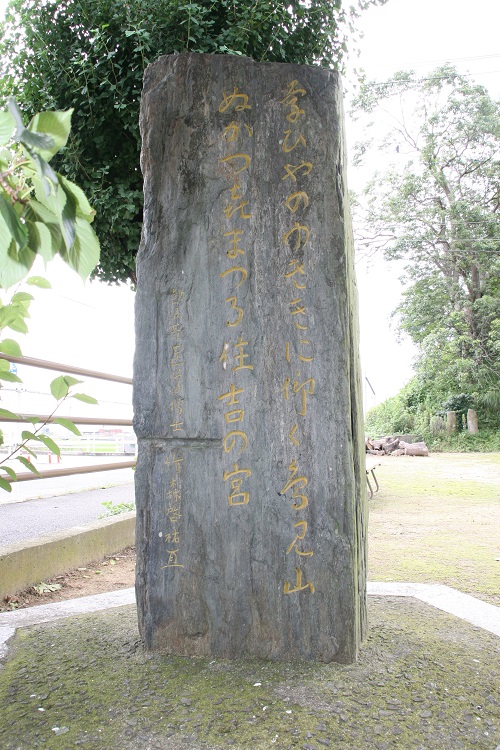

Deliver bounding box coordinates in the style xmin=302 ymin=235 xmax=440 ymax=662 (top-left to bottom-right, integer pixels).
xmin=0 ymin=0 xmax=500 ymax=415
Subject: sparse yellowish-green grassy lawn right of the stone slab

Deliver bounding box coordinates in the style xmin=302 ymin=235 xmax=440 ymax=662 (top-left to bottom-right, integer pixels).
xmin=368 ymin=453 xmax=500 ymax=604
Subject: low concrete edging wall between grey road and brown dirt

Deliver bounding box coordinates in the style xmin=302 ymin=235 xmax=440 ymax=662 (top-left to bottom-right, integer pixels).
xmin=0 ymin=511 xmax=135 ymax=598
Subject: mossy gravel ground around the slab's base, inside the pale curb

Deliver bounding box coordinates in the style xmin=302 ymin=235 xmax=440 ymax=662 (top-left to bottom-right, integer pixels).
xmin=0 ymin=597 xmax=500 ymax=750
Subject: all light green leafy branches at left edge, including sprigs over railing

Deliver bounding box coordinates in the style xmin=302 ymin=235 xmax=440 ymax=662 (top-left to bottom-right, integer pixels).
xmin=0 ymin=99 xmax=99 ymax=492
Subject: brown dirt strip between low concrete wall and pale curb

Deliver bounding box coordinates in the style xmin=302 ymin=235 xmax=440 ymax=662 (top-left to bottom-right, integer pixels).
xmin=0 ymin=547 xmax=135 ymax=612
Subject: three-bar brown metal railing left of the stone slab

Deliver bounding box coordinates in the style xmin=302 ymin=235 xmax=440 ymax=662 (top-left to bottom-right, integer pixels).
xmin=0 ymin=357 xmax=136 ymax=482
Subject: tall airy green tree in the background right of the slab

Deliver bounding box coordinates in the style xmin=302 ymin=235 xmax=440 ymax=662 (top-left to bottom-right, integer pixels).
xmin=356 ymin=66 xmax=500 ymax=426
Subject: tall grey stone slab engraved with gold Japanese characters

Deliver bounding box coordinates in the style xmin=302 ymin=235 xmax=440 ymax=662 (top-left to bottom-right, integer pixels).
xmin=134 ymin=54 xmax=366 ymax=662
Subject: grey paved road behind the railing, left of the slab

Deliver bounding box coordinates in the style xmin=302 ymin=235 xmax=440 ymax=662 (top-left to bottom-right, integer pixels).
xmin=0 ymin=482 xmax=134 ymax=545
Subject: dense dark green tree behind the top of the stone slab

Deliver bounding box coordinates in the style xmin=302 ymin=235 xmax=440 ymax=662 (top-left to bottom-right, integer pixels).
xmin=0 ymin=0 xmax=385 ymax=282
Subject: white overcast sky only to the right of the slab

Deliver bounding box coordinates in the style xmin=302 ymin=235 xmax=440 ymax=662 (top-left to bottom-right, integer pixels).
xmin=346 ymin=0 xmax=500 ymax=406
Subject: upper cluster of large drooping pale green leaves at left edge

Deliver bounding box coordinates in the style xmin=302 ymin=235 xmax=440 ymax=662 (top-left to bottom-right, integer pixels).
xmin=0 ymin=99 xmax=99 ymax=289
